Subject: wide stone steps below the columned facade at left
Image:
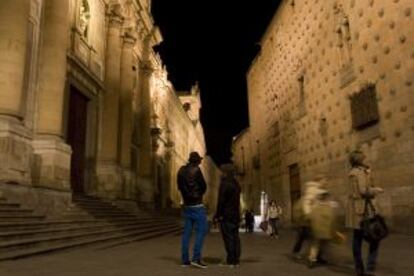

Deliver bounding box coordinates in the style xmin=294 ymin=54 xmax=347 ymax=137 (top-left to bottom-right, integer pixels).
xmin=0 ymin=193 xmax=182 ymax=261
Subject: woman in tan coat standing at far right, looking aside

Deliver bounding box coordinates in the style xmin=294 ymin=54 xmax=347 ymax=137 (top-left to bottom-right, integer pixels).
xmin=346 ymin=150 xmax=383 ymax=276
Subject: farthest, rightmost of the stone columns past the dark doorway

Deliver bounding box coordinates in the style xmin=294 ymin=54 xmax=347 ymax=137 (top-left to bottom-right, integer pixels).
xmin=137 ymin=62 xmax=154 ymax=207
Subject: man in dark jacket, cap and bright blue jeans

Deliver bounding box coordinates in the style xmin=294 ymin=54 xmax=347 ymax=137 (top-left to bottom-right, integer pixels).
xmin=177 ymin=152 xmax=207 ymax=268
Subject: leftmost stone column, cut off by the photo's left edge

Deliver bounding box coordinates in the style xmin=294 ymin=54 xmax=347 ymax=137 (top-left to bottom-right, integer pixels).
xmin=0 ymin=0 xmax=31 ymax=184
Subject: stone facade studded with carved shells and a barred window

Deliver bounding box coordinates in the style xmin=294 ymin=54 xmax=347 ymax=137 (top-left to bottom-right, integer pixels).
xmin=233 ymin=0 xmax=414 ymax=233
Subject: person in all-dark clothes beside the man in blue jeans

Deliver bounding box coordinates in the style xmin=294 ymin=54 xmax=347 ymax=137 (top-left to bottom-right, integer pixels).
xmin=215 ymin=164 xmax=241 ymax=267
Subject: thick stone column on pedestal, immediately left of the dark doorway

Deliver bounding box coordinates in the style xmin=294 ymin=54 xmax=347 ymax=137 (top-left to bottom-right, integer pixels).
xmin=33 ymin=0 xmax=72 ymax=190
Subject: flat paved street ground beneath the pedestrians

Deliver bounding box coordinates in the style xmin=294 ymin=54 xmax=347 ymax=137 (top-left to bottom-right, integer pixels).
xmin=0 ymin=232 xmax=414 ymax=276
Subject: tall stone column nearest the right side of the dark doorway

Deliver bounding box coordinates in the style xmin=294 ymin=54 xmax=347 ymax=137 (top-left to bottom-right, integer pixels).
xmin=97 ymin=12 xmax=123 ymax=199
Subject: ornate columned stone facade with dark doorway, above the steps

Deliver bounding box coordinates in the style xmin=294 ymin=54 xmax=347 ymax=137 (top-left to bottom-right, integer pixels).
xmin=0 ymin=0 xmax=217 ymax=215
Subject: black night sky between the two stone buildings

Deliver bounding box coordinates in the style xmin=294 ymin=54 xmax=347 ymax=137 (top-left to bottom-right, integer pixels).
xmin=152 ymin=0 xmax=280 ymax=164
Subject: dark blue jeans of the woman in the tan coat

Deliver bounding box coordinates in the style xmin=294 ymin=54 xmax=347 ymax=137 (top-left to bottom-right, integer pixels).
xmin=352 ymin=229 xmax=379 ymax=273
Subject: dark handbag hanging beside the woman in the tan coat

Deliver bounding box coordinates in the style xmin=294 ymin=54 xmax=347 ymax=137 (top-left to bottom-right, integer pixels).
xmin=360 ymin=198 xmax=389 ymax=242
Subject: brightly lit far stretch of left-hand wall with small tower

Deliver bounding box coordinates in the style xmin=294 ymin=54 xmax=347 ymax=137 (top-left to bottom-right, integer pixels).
xmin=151 ymin=69 xmax=220 ymax=212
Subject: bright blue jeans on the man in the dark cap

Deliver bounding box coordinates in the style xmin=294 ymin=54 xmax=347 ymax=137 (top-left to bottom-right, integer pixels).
xmin=181 ymin=206 xmax=207 ymax=263
